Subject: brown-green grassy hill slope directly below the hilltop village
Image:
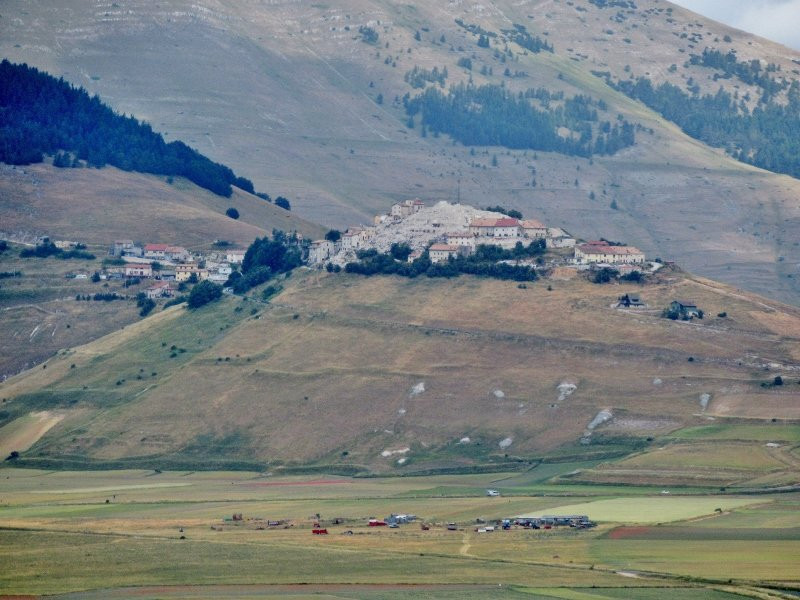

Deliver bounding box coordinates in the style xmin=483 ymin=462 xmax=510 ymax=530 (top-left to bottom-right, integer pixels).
xmin=0 ymin=272 xmax=800 ymax=486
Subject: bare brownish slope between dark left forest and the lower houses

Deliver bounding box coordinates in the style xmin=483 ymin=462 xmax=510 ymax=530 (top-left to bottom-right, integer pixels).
xmin=0 ymin=165 xmax=323 ymax=249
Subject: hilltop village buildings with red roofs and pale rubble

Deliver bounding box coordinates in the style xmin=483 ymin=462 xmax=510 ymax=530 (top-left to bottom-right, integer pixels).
xmin=308 ymin=198 xmax=646 ymax=273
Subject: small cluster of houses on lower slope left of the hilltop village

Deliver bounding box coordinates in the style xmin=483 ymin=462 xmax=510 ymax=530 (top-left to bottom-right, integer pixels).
xmin=101 ymin=240 xmax=246 ymax=298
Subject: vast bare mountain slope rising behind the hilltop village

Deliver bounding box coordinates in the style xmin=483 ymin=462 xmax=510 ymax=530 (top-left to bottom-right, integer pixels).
xmin=0 ymin=0 xmax=800 ymax=303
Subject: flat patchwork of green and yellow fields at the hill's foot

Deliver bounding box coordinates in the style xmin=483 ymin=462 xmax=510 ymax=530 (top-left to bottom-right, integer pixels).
xmin=0 ymin=468 xmax=800 ymax=600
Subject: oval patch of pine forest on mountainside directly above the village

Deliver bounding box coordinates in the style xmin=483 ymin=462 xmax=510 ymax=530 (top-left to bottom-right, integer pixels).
xmin=403 ymin=84 xmax=635 ymax=157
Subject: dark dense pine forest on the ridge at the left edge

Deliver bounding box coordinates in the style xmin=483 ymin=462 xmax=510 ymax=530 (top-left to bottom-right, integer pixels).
xmin=0 ymin=60 xmax=254 ymax=196
